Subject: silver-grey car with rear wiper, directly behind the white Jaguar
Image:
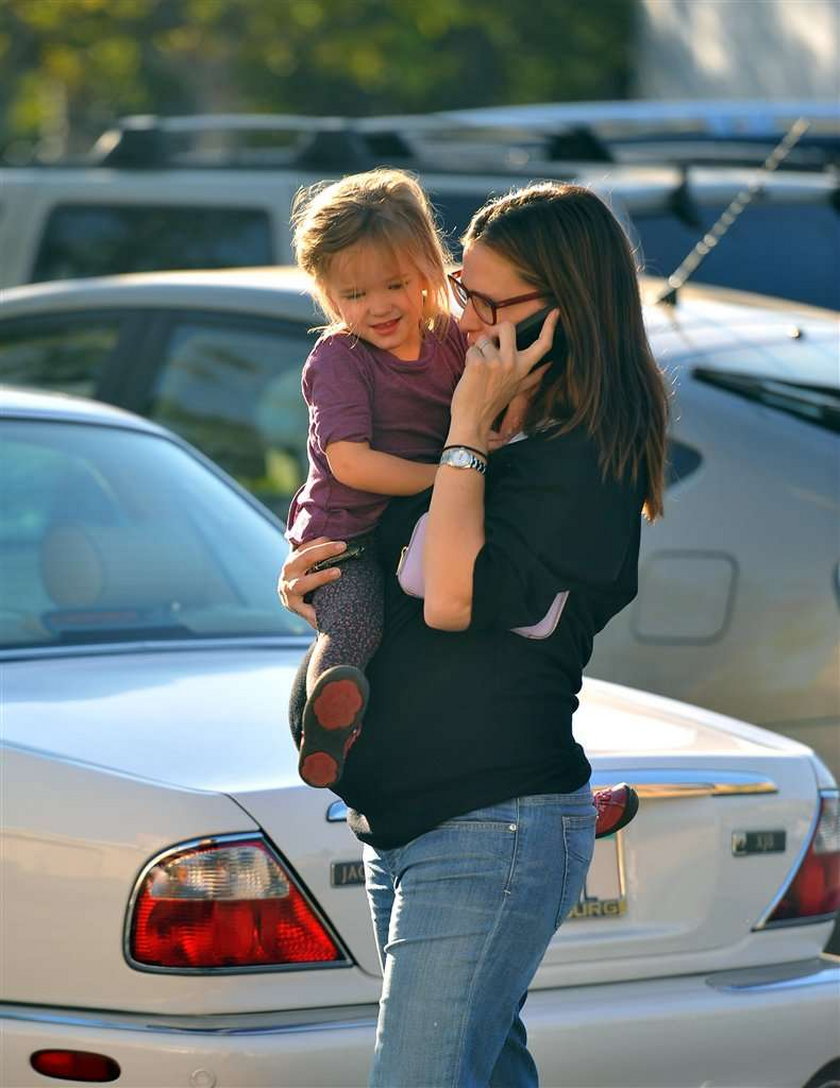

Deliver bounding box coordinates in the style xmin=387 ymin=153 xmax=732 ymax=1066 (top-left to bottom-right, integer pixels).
xmin=0 ymin=269 xmax=840 ymax=775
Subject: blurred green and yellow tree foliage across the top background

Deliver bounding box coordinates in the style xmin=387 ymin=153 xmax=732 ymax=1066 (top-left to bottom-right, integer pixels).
xmin=0 ymin=0 xmax=635 ymax=157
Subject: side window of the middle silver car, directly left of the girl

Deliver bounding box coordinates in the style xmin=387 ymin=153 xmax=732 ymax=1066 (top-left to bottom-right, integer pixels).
xmin=145 ymin=321 xmax=311 ymax=516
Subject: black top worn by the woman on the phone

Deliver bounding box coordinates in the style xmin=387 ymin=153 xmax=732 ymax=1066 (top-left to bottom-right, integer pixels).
xmin=336 ymin=430 xmax=644 ymax=849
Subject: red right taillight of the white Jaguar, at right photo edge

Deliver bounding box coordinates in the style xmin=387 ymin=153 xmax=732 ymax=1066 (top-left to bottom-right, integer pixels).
xmin=765 ymin=791 xmax=840 ymax=927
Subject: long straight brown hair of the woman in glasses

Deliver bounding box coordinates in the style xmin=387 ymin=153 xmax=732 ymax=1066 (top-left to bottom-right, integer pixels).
xmin=462 ymin=182 xmax=668 ymax=520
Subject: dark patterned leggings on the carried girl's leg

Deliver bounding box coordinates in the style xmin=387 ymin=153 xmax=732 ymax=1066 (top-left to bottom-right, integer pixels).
xmin=306 ymin=547 xmax=384 ymax=694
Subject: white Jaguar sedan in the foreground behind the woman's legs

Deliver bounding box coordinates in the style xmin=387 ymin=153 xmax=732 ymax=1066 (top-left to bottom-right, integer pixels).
xmin=0 ymin=392 xmax=840 ymax=1088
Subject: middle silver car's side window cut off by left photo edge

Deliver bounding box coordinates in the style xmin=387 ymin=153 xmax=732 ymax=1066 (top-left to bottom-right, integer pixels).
xmin=0 ymin=318 xmax=120 ymax=396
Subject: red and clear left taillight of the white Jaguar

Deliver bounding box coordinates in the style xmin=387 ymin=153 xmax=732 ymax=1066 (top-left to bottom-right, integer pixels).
xmin=128 ymin=837 xmax=346 ymax=970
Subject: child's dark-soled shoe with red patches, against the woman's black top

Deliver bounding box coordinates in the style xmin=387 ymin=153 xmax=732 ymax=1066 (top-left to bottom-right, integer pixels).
xmin=297 ymin=665 xmax=368 ymax=790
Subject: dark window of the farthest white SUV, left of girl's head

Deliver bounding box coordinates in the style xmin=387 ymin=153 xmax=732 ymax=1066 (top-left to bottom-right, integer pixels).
xmin=32 ymin=205 xmax=274 ymax=281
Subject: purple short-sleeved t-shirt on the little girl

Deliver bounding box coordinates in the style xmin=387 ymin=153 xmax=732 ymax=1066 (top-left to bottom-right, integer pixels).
xmin=286 ymin=319 xmax=467 ymax=546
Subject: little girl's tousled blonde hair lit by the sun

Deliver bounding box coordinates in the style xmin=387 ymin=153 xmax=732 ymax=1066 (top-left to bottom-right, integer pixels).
xmin=292 ymin=169 xmax=450 ymax=331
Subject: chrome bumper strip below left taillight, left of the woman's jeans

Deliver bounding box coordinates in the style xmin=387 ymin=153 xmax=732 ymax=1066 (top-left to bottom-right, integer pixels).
xmin=0 ymin=1004 xmax=378 ymax=1036
